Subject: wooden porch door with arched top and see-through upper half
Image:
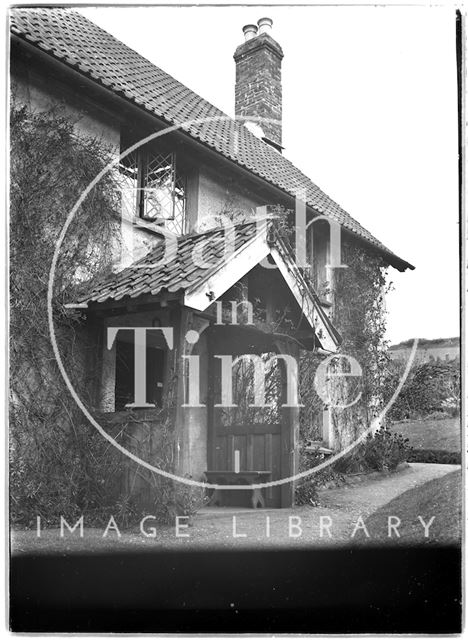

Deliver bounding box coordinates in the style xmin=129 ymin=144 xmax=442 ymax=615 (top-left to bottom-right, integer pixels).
xmin=207 ymin=326 xmax=298 ymax=508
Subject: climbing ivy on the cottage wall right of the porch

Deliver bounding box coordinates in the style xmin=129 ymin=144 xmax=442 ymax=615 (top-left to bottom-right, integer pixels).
xmin=264 ymin=207 xmax=396 ymax=448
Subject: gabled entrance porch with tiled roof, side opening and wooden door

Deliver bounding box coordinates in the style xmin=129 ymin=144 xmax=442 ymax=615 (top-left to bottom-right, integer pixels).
xmin=67 ymin=223 xmax=340 ymax=508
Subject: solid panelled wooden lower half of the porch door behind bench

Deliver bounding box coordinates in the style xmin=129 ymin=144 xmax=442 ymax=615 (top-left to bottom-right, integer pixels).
xmin=213 ymin=423 xmax=282 ymax=508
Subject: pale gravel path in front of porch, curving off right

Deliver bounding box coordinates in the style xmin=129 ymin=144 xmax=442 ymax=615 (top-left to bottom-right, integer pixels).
xmin=12 ymin=463 xmax=460 ymax=554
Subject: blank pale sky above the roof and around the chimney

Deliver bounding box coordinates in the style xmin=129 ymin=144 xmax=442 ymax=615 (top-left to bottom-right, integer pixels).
xmin=80 ymin=5 xmax=459 ymax=343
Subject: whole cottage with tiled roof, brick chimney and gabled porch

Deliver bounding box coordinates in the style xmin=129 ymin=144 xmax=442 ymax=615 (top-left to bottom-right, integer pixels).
xmin=11 ymin=8 xmax=412 ymax=507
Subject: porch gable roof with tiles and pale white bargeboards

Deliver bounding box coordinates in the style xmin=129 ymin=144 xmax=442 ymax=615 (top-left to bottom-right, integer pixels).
xmin=67 ymin=221 xmax=341 ymax=351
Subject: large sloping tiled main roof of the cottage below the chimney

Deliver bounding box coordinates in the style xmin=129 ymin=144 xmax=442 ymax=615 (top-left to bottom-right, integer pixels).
xmin=11 ymin=8 xmax=413 ymax=270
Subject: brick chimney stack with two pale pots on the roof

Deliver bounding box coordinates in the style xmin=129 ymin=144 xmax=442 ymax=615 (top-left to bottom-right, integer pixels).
xmin=234 ymin=18 xmax=283 ymax=151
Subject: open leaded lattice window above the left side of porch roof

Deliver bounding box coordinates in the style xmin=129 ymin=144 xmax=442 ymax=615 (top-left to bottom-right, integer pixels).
xmin=119 ymin=141 xmax=186 ymax=235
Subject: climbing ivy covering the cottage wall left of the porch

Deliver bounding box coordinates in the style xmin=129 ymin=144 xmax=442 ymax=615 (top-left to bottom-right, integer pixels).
xmin=10 ymin=101 xmax=135 ymax=526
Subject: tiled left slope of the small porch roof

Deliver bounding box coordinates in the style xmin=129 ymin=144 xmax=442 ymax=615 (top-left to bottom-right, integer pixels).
xmin=73 ymin=222 xmax=257 ymax=304
